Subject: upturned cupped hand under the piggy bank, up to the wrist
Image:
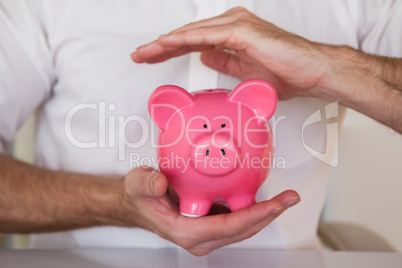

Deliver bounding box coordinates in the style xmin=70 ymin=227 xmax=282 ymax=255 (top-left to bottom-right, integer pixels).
xmin=122 ymin=168 xmax=300 ymax=256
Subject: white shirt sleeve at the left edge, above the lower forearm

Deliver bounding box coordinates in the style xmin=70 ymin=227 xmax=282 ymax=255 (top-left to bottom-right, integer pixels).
xmin=0 ymin=0 xmax=54 ymax=153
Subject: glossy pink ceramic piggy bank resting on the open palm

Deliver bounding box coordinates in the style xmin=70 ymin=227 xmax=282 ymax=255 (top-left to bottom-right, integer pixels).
xmin=148 ymin=79 xmax=277 ymax=217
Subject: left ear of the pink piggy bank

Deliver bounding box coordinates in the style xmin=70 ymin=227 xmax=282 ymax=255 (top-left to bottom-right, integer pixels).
xmin=148 ymin=85 xmax=194 ymax=130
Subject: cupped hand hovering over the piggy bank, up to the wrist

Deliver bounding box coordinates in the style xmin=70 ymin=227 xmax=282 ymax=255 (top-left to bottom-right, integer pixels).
xmin=131 ymin=8 xmax=327 ymax=99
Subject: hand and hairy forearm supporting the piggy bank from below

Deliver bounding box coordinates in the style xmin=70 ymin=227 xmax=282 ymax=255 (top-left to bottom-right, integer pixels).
xmin=0 ymin=155 xmax=300 ymax=255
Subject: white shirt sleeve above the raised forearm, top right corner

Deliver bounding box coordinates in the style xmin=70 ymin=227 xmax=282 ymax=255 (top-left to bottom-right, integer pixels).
xmin=360 ymin=0 xmax=402 ymax=58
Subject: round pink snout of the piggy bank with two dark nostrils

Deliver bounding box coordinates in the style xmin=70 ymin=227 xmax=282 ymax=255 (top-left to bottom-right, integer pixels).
xmin=192 ymin=133 xmax=239 ymax=176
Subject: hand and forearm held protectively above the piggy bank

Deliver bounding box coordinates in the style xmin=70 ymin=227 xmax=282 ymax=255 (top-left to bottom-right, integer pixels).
xmin=131 ymin=8 xmax=402 ymax=133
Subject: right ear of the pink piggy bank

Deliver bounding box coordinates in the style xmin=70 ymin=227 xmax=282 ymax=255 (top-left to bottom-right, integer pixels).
xmin=229 ymin=79 xmax=278 ymax=125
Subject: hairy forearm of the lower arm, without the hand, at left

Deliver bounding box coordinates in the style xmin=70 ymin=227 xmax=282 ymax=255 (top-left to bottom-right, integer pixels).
xmin=0 ymin=155 xmax=124 ymax=233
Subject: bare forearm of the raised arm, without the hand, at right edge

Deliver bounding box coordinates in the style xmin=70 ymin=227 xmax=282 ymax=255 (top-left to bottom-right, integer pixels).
xmin=314 ymin=46 xmax=402 ymax=133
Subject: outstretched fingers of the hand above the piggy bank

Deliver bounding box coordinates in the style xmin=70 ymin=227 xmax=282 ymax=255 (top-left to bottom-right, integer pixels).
xmin=131 ymin=8 xmax=260 ymax=63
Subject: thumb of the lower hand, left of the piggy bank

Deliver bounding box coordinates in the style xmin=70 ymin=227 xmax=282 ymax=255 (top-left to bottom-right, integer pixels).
xmin=125 ymin=167 xmax=168 ymax=198
